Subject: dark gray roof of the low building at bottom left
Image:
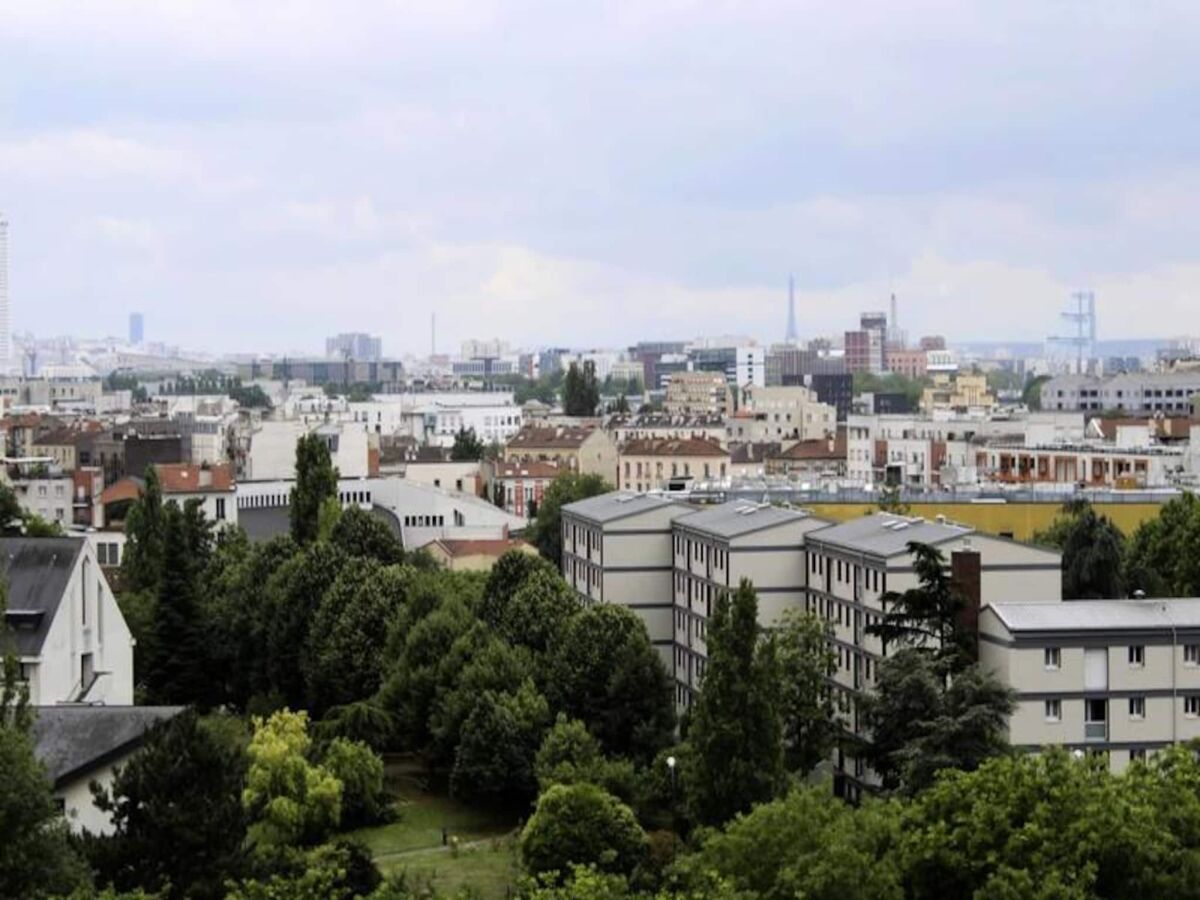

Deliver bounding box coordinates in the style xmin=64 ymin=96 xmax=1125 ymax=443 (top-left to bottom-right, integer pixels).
xmin=34 ymin=706 xmax=184 ymax=786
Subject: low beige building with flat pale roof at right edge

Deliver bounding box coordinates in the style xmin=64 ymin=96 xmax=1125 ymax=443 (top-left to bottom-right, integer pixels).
xmin=979 ymin=594 xmax=1200 ymax=772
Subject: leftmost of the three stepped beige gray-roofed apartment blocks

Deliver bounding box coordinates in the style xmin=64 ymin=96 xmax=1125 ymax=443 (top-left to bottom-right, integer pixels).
xmin=562 ymin=492 xmax=694 ymax=672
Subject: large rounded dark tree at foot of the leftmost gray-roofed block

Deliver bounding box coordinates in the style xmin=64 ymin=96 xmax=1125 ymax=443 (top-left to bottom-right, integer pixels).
xmin=549 ymin=602 xmax=676 ymax=762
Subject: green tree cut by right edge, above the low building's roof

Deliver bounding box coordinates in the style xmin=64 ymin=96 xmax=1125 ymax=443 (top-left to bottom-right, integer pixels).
xmin=1124 ymin=493 xmax=1200 ymax=596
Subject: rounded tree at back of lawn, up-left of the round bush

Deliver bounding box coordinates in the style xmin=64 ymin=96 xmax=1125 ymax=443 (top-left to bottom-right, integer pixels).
xmin=450 ymin=678 xmax=550 ymax=803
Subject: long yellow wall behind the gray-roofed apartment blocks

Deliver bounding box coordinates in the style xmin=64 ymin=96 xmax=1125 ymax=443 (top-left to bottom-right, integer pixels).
xmin=805 ymin=503 xmax=1162 ymax=540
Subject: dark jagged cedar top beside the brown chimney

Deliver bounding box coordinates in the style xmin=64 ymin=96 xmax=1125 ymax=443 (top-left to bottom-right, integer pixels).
xmin=866 ymin=541 xmax=976 ymax=666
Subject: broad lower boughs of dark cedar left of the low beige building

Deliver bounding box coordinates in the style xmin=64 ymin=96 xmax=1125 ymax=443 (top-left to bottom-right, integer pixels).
xmin=862 ymin=648 xmax=1015 ymax=793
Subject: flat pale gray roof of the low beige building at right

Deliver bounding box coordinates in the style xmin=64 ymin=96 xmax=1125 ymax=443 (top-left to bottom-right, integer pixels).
xmin=991 ymin=598 xmax=1200 ymax=634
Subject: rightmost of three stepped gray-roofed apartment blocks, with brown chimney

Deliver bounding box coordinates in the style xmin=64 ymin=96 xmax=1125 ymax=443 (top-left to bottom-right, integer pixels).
xmin=804 ymin=514 xmax=1062 ymax=797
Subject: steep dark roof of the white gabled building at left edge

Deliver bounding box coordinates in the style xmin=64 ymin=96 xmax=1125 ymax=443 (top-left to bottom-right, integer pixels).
xmin=0 ymin=538 xmax=84 ymax=656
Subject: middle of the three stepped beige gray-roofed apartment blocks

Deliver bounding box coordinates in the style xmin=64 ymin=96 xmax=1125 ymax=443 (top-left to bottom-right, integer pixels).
xmin=671 ymin=500 xmax=829 ymax=709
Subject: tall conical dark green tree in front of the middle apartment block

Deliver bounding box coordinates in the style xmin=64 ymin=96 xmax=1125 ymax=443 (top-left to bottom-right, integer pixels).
xmin=684 ymin=580 xmax=784 ymax=826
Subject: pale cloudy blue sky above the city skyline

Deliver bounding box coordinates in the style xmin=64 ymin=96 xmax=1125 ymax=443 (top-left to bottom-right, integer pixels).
xmin=0 ymin=0 xmax=1200 ymax=355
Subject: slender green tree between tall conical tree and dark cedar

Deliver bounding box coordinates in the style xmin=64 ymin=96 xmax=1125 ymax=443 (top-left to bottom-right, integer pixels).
xmin=775 ymin=611 xmax=839 ymax=773
